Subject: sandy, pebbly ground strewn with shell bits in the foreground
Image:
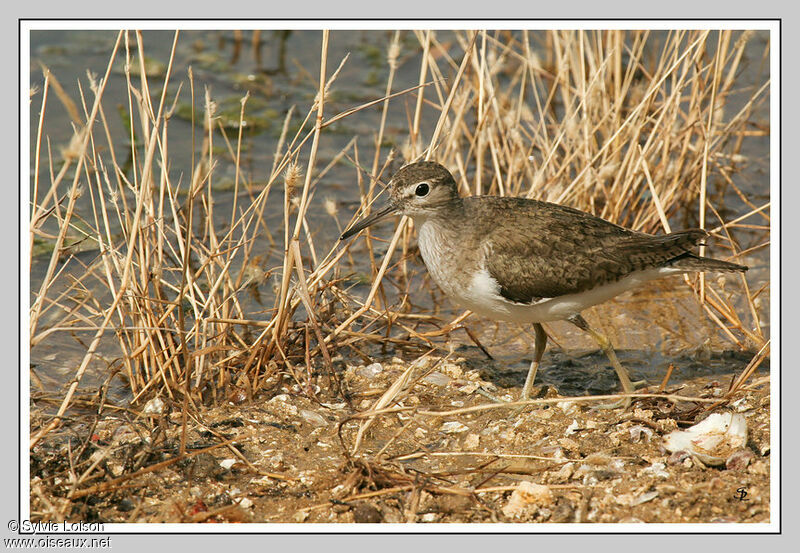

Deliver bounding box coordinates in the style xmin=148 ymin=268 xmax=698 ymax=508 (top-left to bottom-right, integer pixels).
xmin=31 ymin=352 xmax=770 ymax=523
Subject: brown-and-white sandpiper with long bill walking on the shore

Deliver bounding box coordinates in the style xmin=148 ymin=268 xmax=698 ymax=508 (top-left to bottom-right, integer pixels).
xmin=341 ymin=161 xmax=747 ymax=406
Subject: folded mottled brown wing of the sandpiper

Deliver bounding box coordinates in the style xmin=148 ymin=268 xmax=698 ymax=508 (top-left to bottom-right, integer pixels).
xmin=476 ymin=198 xmax=706 ymax=303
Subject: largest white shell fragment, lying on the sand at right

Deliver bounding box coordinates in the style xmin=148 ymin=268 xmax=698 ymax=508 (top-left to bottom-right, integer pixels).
xmin=664 ymin=413 xmax=747 ymax=466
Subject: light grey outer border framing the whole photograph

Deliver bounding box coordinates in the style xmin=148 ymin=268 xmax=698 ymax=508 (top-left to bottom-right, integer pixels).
xmin=7 ymin=0 xmax=800 ymax=552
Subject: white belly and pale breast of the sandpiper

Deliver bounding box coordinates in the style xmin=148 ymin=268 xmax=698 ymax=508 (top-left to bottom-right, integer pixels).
xmin=419 ymin=223 xmax=683 ymax=323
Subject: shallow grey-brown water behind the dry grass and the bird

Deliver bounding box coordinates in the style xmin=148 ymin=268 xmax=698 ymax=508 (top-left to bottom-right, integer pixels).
xmin=30 ymin=31 xmax=769 ymax=399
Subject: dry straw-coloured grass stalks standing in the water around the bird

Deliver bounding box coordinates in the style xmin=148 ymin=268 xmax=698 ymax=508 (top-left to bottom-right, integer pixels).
xmin=30 ymin=31 xmax=770 ymax=506
